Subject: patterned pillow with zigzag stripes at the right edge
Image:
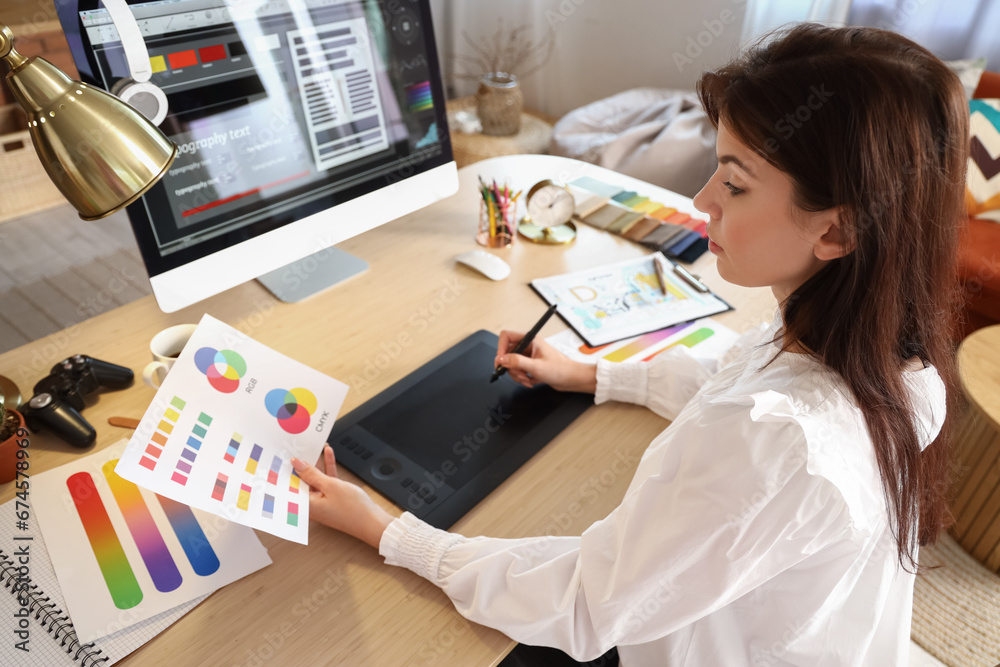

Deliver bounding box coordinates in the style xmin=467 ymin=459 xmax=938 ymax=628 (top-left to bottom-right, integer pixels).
xmin=965 ymin=100 xmax=1000 ymax=222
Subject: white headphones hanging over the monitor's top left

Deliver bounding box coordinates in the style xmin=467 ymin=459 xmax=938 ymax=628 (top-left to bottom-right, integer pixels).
xmin=103 ymin=0 xmax=167 ymax=125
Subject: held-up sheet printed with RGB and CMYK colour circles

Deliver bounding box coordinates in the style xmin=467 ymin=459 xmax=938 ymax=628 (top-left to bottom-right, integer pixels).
xmin=116 ymin=315 xmax=347 ymax=544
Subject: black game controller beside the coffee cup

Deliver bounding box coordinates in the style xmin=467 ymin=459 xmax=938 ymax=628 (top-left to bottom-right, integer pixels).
xmin=21 ymin=354 xmax=135 ymax=447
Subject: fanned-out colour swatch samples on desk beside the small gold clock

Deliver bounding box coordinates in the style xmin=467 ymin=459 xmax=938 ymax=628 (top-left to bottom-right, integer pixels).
xmin=569 ymin=176 xmax=708 ymax=262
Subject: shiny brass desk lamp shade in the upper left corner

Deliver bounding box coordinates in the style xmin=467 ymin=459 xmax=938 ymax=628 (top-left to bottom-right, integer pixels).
xmin=0 ymin=25 xmax=177 ymax=220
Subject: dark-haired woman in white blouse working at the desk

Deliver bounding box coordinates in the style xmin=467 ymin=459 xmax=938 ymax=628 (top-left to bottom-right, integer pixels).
xmin=295 ymin=25 xmax=968 ymax=667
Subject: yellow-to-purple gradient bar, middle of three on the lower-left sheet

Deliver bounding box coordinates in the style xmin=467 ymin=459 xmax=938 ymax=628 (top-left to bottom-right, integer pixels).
xmin=103 ymin=459 xmax=182 ymax=593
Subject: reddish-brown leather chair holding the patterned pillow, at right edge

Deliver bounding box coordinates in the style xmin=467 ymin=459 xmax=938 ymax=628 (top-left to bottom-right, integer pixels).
xmin=958 ymin=72 xmax=1000 ymax=338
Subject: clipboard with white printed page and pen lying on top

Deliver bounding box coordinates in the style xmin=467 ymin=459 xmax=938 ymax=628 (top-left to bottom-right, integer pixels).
xmin=530 ymin=253 xmax=733 ymax=347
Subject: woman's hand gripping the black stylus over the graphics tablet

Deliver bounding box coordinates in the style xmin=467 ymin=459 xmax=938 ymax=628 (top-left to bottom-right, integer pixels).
xmin=493 ymin=331 xmax=597 ymax=394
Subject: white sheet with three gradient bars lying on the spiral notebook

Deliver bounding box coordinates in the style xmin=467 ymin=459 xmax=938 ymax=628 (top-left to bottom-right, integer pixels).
xmin=31 ymin=440 xmax=271 ymax=643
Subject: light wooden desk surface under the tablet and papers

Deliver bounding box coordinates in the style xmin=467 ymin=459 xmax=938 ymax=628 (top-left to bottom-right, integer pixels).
xmin=0 ymin=156 xmax=774 ymax=667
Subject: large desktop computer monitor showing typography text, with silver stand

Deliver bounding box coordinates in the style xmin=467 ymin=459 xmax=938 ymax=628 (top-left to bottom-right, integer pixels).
xmin=56 ymin=0 xmax=458 ymax=312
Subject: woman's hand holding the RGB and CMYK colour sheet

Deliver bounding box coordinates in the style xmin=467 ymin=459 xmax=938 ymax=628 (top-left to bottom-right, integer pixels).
xmin=292 ymin=445 xmax=395 ymax=549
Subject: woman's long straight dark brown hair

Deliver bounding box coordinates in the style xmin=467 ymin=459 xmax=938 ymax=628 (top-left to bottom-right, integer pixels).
xmin=698 ymin=24 xmax=969 ymax=570
